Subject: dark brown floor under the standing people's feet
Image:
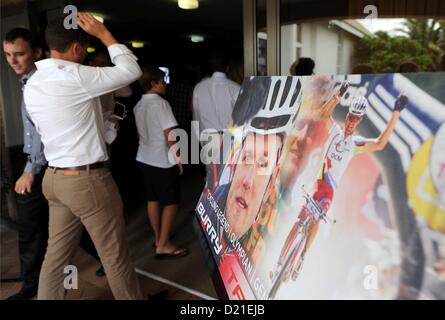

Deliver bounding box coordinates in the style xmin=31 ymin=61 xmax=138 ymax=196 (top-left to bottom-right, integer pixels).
xmin=0 ymin=171 xmax=217 ymax=300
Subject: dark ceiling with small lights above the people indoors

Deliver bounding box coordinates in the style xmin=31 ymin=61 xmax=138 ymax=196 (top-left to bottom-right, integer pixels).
xmin=1 ymin=0 xmax=243 ymax=70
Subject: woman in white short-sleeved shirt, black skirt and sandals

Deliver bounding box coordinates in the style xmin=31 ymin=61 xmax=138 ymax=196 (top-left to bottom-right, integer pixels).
xmin=133 ymin=66 xmax=188 ymax=259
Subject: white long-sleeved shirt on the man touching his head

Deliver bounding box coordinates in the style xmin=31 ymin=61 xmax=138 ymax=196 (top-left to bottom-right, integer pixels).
xmin=24 ymin=44 xmax=142 ymax=168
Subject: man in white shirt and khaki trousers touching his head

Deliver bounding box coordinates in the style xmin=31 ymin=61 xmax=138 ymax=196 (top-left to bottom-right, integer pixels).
xmin=24 ymin=13 xmax=142 ymax=299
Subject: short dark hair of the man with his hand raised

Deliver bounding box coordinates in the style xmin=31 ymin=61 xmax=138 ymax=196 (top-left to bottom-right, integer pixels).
xmin=45 ymin=16 xmax=89 ymax=53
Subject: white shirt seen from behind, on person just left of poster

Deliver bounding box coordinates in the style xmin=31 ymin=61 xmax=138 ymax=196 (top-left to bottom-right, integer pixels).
xmin=193 ymin=72 xmax=240 ymax=138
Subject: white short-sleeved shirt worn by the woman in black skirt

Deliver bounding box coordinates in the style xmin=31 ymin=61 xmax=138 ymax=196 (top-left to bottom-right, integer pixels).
xmin=133 ymin=93 xmax=178 ymax=168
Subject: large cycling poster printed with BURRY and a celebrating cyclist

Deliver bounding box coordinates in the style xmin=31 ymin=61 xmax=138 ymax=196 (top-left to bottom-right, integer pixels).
xmin=196 ymin=73 xmax=445 ymax=299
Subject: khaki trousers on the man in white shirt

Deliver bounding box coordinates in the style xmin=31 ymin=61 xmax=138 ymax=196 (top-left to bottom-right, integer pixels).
xmin=37 ymin=168 xmax=142 ymax=299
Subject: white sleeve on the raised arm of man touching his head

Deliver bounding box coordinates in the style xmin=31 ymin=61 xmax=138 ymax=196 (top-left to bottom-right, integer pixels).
xmin=78 ymin=44 xmax=142 ymax=97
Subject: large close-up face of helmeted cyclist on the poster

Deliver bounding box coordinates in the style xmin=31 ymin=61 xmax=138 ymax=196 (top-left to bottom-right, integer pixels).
xmin=225 ymin=133 xmax=282 ymax=238
